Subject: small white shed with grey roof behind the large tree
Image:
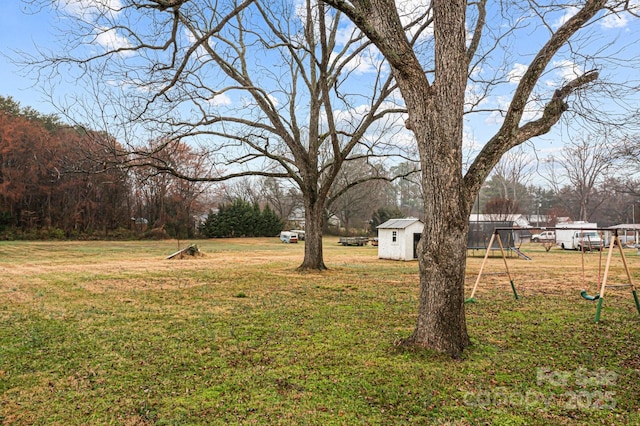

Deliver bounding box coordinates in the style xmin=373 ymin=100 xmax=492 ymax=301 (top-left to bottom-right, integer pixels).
xmin=377 ymin=217 xmax=424 ymax=260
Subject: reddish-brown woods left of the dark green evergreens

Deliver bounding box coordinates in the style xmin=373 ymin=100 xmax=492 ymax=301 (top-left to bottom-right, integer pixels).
xmin=0 ymin=96 xmax=206 ymax=239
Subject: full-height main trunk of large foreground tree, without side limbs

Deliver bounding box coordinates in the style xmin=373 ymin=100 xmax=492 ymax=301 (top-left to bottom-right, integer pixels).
xmin=395 ymin=0 xmax=473 ymax=358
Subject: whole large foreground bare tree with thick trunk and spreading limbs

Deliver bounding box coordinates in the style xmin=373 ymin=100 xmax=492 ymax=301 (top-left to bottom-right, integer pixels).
xmin=325 ymin=0 xmax=637 ymax=357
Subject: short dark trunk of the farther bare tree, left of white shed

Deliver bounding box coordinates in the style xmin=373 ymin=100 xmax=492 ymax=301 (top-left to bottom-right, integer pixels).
xmin=298 ymin=197 xmax=327 ymax=271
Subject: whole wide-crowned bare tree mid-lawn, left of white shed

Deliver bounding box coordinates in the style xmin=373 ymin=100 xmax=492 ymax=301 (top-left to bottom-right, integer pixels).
xmin=23 ymin=0 xmax=410 ymax=270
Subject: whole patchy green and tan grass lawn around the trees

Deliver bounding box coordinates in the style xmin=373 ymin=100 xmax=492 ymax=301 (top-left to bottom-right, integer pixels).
xmin=0 ymin=237 xmax=640 ymax=425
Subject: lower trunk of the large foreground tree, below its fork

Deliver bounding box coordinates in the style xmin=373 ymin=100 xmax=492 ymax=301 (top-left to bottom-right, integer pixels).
xmin=405 ymin=97 xmax=473 ymax=358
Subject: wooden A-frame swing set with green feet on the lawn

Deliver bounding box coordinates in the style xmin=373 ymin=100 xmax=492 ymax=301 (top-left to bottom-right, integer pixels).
xmin=465 ymin=228 xmax=640 ymax=322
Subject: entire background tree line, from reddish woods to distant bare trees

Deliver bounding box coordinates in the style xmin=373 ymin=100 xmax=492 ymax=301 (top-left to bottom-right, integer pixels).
xmin=0 ymin=92 xmax=640 ymax=239
